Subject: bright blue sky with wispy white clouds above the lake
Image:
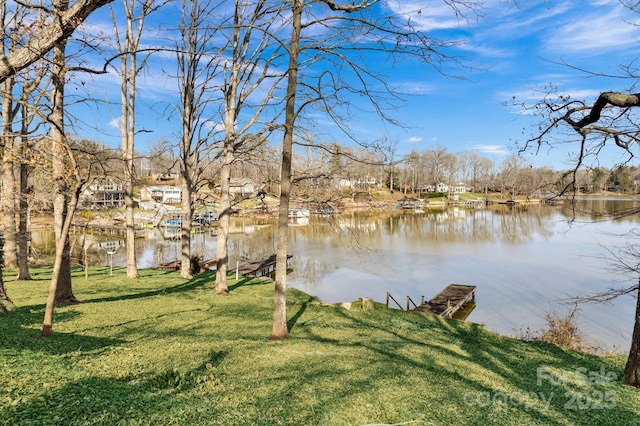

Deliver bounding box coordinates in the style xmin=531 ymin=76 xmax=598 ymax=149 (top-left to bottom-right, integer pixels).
xmin=72 ymin=0 xmax=640 ymax=169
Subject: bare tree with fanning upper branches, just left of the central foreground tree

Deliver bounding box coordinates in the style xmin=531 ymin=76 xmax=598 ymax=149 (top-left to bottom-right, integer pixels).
xmin=209 ymin=0 xmax=284 ymax=295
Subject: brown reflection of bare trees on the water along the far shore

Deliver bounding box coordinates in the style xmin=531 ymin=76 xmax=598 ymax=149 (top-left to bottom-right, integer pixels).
xmin=32 ymin=203 xmax=564 ymax=270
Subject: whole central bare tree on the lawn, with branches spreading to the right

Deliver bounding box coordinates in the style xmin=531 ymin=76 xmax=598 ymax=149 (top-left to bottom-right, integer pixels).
xmin=264 ymin=0 xmax=472 ymax=340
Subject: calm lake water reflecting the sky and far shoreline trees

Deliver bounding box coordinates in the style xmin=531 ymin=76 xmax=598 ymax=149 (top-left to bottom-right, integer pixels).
xmin=33 ymin=197 xmax=640 ymax=352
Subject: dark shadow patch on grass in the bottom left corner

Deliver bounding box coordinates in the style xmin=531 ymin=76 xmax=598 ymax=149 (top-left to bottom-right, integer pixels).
xmin=0 ymin=351 xmax=227 ymax=426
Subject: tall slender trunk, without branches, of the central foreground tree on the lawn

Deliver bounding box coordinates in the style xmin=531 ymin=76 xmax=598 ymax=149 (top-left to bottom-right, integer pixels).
xmin=269 ymin=0 xmax=304 ymax=340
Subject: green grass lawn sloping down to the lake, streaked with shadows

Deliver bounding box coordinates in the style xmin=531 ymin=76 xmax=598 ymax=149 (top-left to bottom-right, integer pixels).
xmin=0 ymin=268 xmax=640 ymax=425
